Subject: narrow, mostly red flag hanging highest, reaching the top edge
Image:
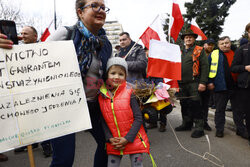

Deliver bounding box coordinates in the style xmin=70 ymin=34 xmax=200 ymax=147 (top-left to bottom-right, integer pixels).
xmin=170 ymin=0 xmax=184 ymax=41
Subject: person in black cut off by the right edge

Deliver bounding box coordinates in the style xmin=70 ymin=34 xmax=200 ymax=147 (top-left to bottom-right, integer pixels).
xmin=231 ymin=23 xmax=250 ymax=145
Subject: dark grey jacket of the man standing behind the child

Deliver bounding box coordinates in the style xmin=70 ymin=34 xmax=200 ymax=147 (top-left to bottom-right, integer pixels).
xmin=115 ymin=41 xmax=147 ymax=83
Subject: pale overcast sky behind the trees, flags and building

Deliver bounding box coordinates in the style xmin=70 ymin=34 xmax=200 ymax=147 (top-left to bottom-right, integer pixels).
xmin=16 ymin=0 xmax=250 ymax=41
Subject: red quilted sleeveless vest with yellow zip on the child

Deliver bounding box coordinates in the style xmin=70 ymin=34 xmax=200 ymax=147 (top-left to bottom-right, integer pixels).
xmin=98 ymin=82 xmax=149 ymax=155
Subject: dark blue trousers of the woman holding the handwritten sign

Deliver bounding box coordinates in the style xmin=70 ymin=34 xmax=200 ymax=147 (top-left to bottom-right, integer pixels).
xmin=50 ymin=101 xmax=108 ymax=167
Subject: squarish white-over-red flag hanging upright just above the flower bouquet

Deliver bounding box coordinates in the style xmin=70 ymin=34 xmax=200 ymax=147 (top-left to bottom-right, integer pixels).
xmin=147 ymin=39 xmax=181 ymax=80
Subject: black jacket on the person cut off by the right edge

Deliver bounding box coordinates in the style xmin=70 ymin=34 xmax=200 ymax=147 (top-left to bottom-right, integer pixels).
xmin=231 ymin=42 xmax=250 ymax=88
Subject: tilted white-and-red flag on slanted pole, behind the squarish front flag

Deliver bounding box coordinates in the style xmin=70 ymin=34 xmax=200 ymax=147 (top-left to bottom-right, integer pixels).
xmin=140 ymin=15 xmax=167 ymax=49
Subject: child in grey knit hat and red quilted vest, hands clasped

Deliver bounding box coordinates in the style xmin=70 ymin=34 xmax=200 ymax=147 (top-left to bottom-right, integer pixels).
xmin=98 ymin=57 xmax=149 ymax=167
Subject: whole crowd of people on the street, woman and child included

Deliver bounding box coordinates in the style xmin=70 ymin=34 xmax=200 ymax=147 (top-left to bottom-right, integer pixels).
xmin=0 ymin=0 xmax=250 ymax=167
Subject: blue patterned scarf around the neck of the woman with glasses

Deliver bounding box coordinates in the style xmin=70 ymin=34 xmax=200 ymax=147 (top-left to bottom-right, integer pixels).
xmin=77 ymin=21 xmax=107 ymax=78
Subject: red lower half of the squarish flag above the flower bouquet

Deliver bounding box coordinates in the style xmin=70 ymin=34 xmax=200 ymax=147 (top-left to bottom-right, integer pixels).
xmin=147 ymin=57 xmax=181 ymax=80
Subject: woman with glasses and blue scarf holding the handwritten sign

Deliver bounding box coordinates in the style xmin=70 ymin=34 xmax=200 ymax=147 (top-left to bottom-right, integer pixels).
xmin=0 ymin=0 xmax=112 ymax=167
